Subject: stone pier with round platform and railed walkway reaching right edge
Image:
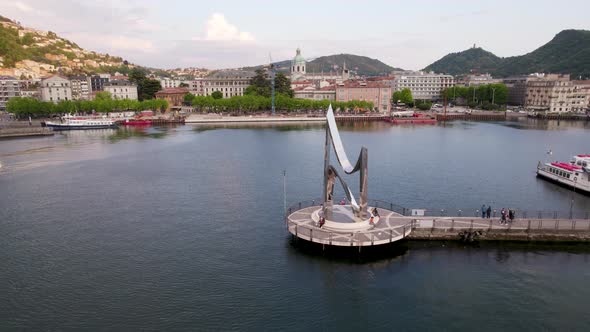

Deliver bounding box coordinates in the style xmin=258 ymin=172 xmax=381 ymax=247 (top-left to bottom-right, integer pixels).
xmin=285 ymin=200 xmax=590 ymax=247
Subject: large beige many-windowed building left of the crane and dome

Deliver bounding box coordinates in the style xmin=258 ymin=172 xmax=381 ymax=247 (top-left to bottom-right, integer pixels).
xmin=202 ymin=70 xmax=255 ymax=98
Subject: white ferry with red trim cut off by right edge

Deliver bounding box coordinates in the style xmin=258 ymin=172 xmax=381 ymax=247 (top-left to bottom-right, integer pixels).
xmin=537 ymin=154 xmax=590 ymax=195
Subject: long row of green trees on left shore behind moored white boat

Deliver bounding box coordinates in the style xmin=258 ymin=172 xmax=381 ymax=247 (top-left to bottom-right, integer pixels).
xmin=6 ymin=92 xmax=168 ymax=118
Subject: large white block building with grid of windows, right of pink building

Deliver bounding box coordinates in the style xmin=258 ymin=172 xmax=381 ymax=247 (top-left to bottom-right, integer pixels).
xmin=393 ymin=72 xmax=455 ymax=100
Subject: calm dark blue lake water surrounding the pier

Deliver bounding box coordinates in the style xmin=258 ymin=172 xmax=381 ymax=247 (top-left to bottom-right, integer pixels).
xmin=0 ymin=120 xmax=590 ymax=331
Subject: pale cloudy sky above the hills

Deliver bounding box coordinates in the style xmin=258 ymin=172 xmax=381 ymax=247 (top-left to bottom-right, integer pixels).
xmin=0 ymin=0 xmax=590 ymax=70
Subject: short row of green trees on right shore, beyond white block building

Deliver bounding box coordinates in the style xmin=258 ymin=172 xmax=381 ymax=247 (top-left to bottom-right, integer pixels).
xmin=443 ymin=83 xmax=508 ymax=109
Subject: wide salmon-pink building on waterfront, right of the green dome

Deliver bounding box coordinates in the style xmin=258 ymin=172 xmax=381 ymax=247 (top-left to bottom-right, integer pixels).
xmin=336 ymin=80 xmax=392 ymax=113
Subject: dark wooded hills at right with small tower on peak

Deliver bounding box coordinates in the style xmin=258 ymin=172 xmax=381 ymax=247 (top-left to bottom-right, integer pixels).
xmin=424 ymin=30 xmax=590 ymax=77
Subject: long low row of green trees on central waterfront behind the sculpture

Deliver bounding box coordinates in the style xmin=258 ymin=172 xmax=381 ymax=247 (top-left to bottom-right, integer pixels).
xmin=192 ymin=94 xmax=374 ymax=113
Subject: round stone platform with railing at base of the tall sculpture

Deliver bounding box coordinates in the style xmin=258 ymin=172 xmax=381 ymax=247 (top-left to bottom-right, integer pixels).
xmin=286 ymin=205 xmax=412 ymax=246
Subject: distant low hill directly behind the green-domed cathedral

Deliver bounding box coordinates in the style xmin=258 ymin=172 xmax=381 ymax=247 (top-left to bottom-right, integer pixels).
xmin=244 ymin=54 xmax=402 ymax=76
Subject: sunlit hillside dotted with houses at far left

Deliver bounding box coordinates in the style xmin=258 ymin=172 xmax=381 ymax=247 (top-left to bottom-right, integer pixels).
xmin=0 ymin=16 xmax=127 ymax=78
